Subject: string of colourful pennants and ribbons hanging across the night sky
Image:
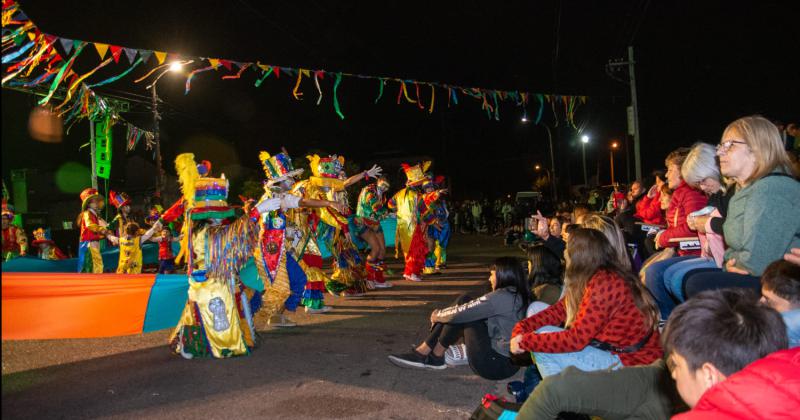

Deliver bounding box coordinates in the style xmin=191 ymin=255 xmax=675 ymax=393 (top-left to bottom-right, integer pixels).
xmin=2 ymin=0 xmax=587 ymax=126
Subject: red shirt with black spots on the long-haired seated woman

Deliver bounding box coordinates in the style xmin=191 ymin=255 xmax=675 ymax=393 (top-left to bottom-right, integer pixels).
xmin=511 ymin=270 xmax=662 ymax=366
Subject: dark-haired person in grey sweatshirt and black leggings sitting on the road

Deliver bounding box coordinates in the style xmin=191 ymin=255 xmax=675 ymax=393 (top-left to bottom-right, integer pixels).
xmin=389 ymin=257 xmax=530 ymax=380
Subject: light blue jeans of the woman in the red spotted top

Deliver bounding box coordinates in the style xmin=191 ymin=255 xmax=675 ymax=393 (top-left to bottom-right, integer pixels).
xmin=531 ymin=325 xmax=622 ymax=378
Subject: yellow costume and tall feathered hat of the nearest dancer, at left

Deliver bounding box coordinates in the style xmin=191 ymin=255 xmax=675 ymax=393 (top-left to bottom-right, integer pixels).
xmin=170 ymin=153 xmax=261 ymax=358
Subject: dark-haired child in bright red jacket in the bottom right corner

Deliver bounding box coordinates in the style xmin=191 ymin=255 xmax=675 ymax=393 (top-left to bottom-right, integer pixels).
xmin=664 ymin=290 xmax=800 ymax=420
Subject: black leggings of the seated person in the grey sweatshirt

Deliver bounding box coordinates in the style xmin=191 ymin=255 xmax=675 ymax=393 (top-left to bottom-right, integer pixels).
xmin=425 ymin=294 xmax=519 ymax=380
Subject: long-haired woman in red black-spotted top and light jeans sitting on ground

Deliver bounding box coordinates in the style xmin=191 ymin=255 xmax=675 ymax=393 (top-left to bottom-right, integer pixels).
xmin=511 ymin=228 xmax=662 ymax=378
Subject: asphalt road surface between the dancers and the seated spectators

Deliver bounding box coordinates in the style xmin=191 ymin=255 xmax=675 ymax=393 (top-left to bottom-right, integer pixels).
xmin=2 ymin=236 xmax=521 ymax=419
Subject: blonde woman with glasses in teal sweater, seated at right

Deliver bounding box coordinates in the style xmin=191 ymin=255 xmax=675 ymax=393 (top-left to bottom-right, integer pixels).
xmin=684 ymin=116 xmax=800 ymax=298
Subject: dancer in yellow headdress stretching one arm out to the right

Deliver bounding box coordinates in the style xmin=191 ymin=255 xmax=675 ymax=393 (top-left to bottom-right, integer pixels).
xmin=298 ymin=155 xmax=382 ymax=297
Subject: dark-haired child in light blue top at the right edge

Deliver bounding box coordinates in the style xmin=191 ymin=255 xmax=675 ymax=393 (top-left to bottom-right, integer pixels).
xmin=761 ymin=260 xmax=800 ymax=347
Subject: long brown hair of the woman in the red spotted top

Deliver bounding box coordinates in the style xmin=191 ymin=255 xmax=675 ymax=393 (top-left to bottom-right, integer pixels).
xmin=564 ymin=228 xmax=658 ymax=330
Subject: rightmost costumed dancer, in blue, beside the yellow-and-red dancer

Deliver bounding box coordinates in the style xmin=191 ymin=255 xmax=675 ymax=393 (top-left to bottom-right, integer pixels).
xmin=423 ymin=175 xmax=450 ymax=274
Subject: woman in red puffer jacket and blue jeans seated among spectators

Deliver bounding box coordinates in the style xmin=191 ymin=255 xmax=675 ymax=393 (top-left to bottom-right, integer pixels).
xmin=644 ymin=147 xmax=708 ymax=320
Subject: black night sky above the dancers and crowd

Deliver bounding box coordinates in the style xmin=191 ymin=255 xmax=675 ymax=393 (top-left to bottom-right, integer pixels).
xmin=2 ymin=0 xmax=800 ymax=202
